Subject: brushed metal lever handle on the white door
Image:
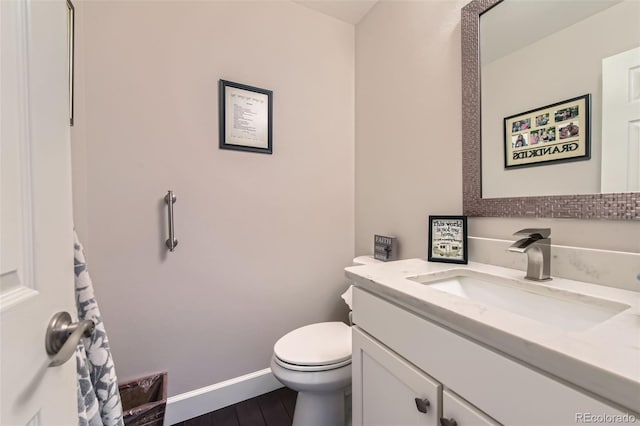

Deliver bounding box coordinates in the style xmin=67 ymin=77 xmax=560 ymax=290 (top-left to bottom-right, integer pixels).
xmin=44 ymin=312 xmax=95 ymax=367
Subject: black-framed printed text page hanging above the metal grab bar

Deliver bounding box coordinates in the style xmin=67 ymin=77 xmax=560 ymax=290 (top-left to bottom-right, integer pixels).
xmin=218 ymin=79 xmax=273 ymax=154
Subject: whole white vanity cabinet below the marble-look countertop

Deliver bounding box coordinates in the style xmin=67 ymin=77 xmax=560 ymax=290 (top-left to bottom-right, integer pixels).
xmin=352 ymin=288 xmax=629 ymax=426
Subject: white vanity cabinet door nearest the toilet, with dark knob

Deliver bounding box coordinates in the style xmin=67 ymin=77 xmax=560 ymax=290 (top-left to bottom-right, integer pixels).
xmin=352 ymin=327 xmax=442 ymax=426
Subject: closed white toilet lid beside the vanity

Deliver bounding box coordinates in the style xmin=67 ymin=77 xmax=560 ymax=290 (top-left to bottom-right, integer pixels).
xmin=273 ymin=321 xmax=351 ymax=365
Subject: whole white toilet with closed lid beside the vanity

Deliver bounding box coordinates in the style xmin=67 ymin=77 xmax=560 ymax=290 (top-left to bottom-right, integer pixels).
xmin=271 ymin=256 xmax=378 ymax=426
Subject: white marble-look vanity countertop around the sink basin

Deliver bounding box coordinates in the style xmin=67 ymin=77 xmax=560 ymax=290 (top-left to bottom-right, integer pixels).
xmin=345 ymin=259 xmax=640 ymax=413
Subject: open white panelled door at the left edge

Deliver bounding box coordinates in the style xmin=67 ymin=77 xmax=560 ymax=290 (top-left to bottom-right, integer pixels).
xmin=0 ymin=0 xmax=78 ymax=426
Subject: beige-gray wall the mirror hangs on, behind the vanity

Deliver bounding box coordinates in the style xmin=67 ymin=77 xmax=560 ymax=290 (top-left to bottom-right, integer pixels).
xmin=356 ymin=1 xmax=640 ymax=256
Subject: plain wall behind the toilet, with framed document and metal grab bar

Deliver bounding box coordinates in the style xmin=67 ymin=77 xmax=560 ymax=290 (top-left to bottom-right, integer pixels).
xmin=73 ymin=1 xmax=354 ymax=395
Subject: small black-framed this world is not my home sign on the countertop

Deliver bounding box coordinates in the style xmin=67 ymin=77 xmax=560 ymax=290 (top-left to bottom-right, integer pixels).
xmin=427 ymin=216 xmax=468 ymax=264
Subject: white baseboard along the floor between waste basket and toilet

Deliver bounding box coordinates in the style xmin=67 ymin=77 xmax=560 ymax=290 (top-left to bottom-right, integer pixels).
xmin=164 ymin=368 xmax=282 ymax=425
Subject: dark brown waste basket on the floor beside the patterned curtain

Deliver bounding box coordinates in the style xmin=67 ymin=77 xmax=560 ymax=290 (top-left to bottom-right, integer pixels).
xmin=118 ymin=371 xmax=167 ymax=426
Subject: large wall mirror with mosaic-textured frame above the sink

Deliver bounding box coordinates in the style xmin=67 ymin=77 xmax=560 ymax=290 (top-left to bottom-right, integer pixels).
xmin=462 ymin=0 xmax=640 ymax=220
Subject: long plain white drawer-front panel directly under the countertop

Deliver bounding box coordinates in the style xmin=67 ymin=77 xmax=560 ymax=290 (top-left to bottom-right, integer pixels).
xmin=353 ymin=288 xmax=625 ymax=426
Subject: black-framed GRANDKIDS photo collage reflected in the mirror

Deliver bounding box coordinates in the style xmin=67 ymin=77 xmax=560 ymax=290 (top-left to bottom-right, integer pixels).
xmin=504 ymin=93 xmax=591 ymax=169
